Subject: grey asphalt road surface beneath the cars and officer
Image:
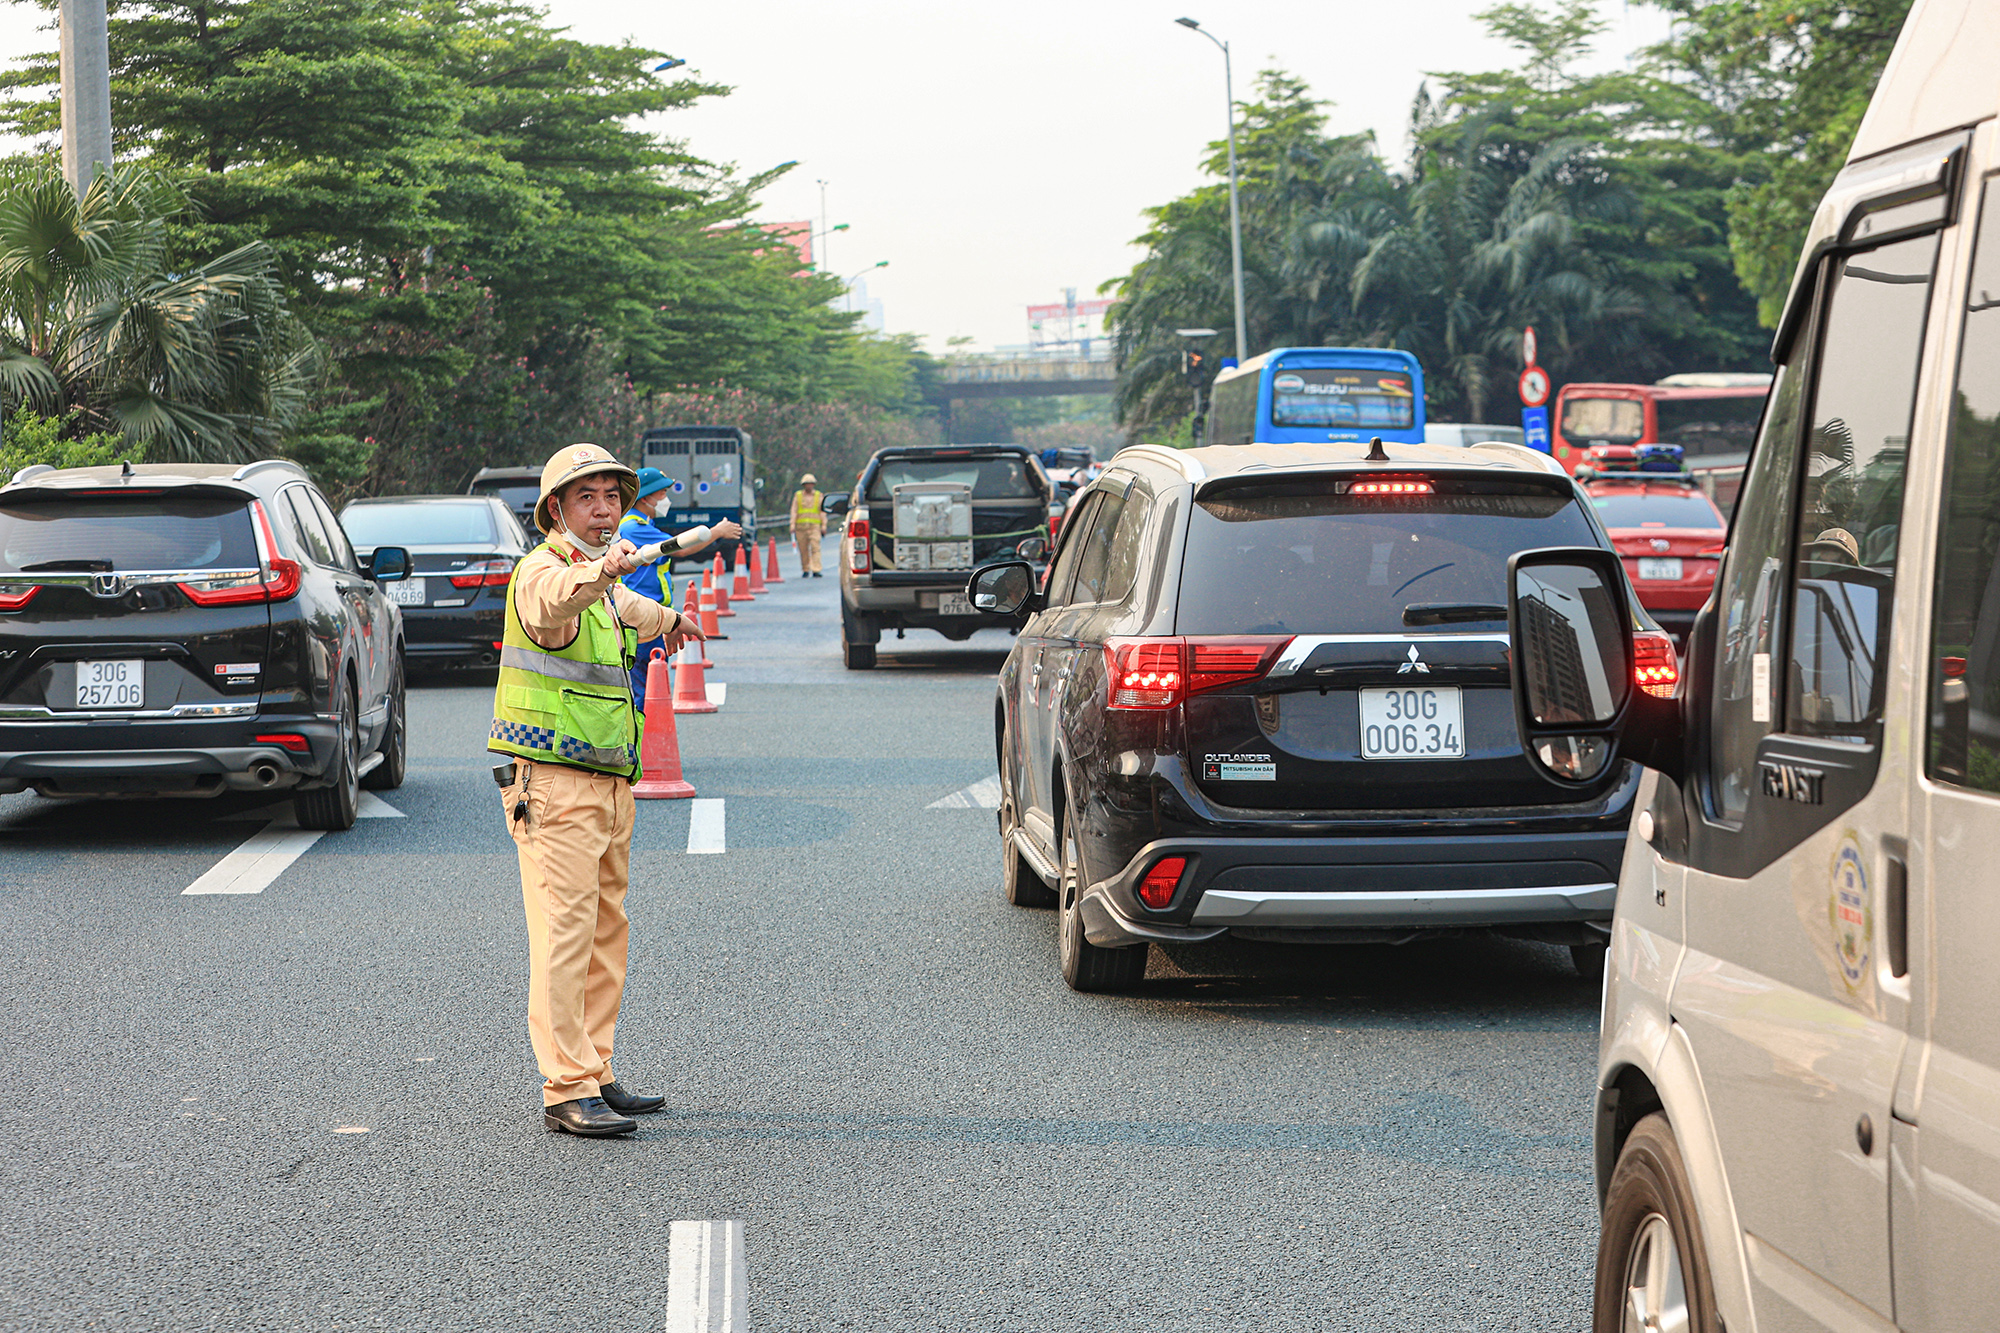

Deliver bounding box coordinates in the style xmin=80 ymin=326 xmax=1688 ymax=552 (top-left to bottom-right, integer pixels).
xmin=0 ymin=552 xmax=1596 ymax=1333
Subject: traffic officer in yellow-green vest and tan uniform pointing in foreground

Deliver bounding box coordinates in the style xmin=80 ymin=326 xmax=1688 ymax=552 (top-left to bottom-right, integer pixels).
xmin=486 ymin=444 xmax=708 ymax=1135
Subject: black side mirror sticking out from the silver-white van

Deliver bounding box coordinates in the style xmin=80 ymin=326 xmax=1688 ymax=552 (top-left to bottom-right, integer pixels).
xmin=1508 ymin=546 xmax=1680 ymax=787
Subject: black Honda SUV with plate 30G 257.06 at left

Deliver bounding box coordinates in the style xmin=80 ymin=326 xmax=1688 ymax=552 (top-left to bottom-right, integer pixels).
xmin=0 ymin=460 xmax=410 ymax=829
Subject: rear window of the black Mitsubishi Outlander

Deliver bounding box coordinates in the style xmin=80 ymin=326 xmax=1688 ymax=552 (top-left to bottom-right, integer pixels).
xmin=1176 ymin=480 xmax=1600 ymax=634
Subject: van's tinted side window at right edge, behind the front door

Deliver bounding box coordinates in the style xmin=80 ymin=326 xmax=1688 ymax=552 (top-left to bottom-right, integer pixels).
xmin=1928 ymin=180 xmax=2000 ymax=791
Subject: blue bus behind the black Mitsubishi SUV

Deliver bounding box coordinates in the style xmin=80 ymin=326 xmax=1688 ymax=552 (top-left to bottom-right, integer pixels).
xmin=1206 ymin=346 xmax=1424 ymax=444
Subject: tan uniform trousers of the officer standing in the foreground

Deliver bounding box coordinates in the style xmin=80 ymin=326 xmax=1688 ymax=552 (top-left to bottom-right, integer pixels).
xmin=500 ymin=761 xmax=632 ymax=1107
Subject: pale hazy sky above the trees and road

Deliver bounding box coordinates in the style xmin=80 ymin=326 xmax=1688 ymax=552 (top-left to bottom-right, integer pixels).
xmin=0 ymin=0 xmax=1666 ymax=352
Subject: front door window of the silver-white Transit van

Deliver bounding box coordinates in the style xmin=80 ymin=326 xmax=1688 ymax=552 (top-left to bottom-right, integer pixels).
xmin=1784 ymin=234 xmax=1938 ymax=741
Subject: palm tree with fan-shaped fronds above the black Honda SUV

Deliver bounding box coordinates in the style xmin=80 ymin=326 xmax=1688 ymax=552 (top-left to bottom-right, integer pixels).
xmin=0 ymin=166 xmax=320 ymax=462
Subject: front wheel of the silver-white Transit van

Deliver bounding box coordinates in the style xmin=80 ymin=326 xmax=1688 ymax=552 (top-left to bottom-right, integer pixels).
xmin=1590 ymin=1111 xmax=1722 ymax=1333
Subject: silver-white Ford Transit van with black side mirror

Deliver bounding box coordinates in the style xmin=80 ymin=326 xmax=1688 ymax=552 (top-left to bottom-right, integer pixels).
xmin=1510 ymin=0 xmax=2000 ymax=1333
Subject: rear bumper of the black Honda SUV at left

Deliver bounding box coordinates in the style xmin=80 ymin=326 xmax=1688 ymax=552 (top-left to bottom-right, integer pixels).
xmin=0 ymin=715 xmax=340 ymax=797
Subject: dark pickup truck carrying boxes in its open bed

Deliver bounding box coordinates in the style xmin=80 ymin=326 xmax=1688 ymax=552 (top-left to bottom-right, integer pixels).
xmin=824 ymin=444 xmax=1056 ymax=671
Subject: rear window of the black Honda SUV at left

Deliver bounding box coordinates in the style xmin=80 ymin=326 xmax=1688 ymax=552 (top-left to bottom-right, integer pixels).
xmin=0 ymin=494 xmax=258 ymax=574
